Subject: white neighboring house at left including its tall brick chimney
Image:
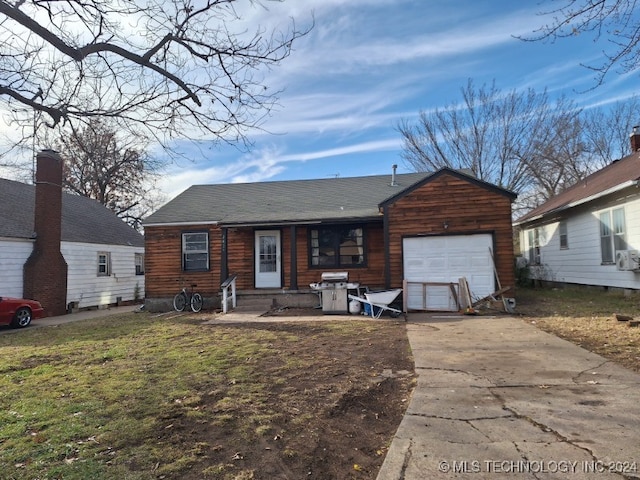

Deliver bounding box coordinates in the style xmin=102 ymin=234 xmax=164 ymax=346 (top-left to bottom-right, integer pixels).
xmin=0 ymin=150 xmax=145 ymax=315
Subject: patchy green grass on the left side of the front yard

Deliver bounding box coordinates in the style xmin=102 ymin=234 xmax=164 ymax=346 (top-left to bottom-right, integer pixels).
xmin=0 ymin=314 xmax=292 ymax=480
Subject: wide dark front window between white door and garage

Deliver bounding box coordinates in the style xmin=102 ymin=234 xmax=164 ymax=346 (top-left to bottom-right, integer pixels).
xmin=309 ymin=226 xmax=365 ymax=267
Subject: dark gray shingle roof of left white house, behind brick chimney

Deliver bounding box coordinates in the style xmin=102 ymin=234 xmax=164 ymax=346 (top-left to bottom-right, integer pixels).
xmin=0 ymin=178 xmax=144 ymax=247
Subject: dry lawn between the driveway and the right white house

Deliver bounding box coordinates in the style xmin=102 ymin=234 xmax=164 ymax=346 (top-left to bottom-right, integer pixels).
xmin=516 ymin=288 xmax=640 ymax=372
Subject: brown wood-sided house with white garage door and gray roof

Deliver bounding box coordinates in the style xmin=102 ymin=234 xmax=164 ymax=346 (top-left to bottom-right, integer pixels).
xmin=143 ymin=166 xmax=515 ymax=310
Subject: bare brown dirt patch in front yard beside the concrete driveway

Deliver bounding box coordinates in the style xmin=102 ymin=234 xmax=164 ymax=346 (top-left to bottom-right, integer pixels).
xmin=158 ymin=318 xmax=414 ymax=480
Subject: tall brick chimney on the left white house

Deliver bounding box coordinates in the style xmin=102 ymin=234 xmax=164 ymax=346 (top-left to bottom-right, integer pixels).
xmin=24 ymin=150 xmax=67 ymax=316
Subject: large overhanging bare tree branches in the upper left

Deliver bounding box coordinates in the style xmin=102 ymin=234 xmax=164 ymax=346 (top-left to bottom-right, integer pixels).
xmin=0 ymin=0 xmax=306 ymax=150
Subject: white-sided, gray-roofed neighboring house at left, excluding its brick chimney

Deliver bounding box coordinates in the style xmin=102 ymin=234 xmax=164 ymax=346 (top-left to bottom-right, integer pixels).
xmin=0 ymin=179 xmax=145 ymax=308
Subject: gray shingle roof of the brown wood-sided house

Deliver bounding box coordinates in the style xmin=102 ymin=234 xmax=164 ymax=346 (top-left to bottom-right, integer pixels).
xmin=144 ymin=172 xmax=430 ymax=225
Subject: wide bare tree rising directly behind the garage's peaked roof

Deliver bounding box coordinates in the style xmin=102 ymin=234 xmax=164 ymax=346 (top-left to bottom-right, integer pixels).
xmin=398 ymin=80 xmax=576 ymax=191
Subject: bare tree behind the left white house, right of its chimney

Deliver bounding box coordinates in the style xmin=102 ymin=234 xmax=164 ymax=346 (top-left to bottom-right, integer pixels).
xmin=56 ymin=118 xmax=162 ymax=229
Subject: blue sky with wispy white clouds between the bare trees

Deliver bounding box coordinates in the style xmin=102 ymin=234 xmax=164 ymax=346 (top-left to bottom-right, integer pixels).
xmin=1 ymin=0 xmax=640 ymax=200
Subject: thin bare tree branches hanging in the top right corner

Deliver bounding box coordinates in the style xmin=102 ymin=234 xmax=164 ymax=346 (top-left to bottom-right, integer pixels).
xmin=519 ymin=0 xmax=640 ymax=85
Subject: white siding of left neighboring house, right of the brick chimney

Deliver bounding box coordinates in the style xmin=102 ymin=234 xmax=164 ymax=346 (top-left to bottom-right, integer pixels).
xmin=60 ymin=242 xmax=145 ymax=308
